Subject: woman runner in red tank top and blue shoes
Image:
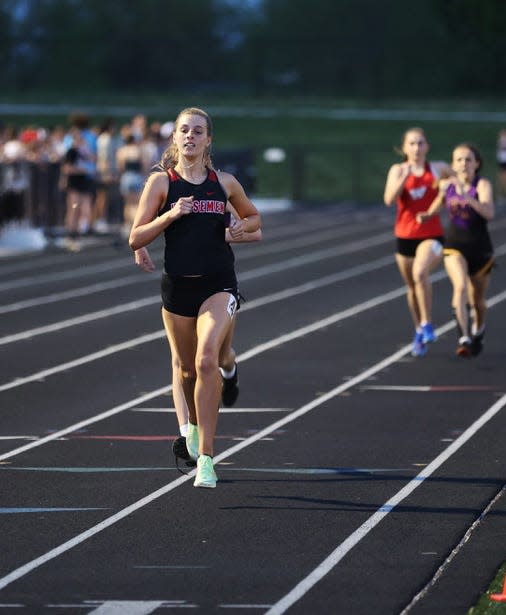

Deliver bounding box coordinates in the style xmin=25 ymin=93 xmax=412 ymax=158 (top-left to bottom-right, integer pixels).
xmin=383 ymin=128 xmax=452 ymax=357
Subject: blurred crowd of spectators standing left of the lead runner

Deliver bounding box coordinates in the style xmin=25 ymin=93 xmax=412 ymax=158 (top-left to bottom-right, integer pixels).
xmin=0 ymin=112 xmax=172 ymax=248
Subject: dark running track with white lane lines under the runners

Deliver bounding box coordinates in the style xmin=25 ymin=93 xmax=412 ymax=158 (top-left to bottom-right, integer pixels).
xmin=0 ymin=206 xmax=506 ymax=615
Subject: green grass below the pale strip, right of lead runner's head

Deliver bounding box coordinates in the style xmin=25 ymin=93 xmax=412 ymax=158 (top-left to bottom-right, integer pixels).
xmin=215 ymin=118 xmax=502 ymax=203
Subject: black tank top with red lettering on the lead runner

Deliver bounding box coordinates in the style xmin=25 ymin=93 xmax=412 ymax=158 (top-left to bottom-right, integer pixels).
xmin=159 ymin=169 xmax=234 ymax=275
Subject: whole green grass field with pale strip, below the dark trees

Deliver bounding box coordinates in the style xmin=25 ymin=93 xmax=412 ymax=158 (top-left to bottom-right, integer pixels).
xmin=0 ymin=94 xmax=506 ymax=203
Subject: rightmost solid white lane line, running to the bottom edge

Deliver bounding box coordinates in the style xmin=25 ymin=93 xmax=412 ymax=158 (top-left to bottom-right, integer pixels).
xmin=266 ymin=395 xmax=506 ymax=615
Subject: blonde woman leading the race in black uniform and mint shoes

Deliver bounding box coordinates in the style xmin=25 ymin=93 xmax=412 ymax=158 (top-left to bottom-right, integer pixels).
xmin=129 ymin=107 xmax=261 ymax=488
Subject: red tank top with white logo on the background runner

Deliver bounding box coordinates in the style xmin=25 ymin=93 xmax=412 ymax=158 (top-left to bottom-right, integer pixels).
xmin=395 ymin=162 xmax=444 ymax=239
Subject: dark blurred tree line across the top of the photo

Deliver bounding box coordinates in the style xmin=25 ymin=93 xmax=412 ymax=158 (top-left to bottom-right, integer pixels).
xmin=0 ymin=0 xmax=506 ymax=100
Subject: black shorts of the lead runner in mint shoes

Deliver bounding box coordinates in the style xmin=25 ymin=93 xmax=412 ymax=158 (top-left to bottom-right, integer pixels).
xmin=161 ymin=272 xmax=240 ymax=318
